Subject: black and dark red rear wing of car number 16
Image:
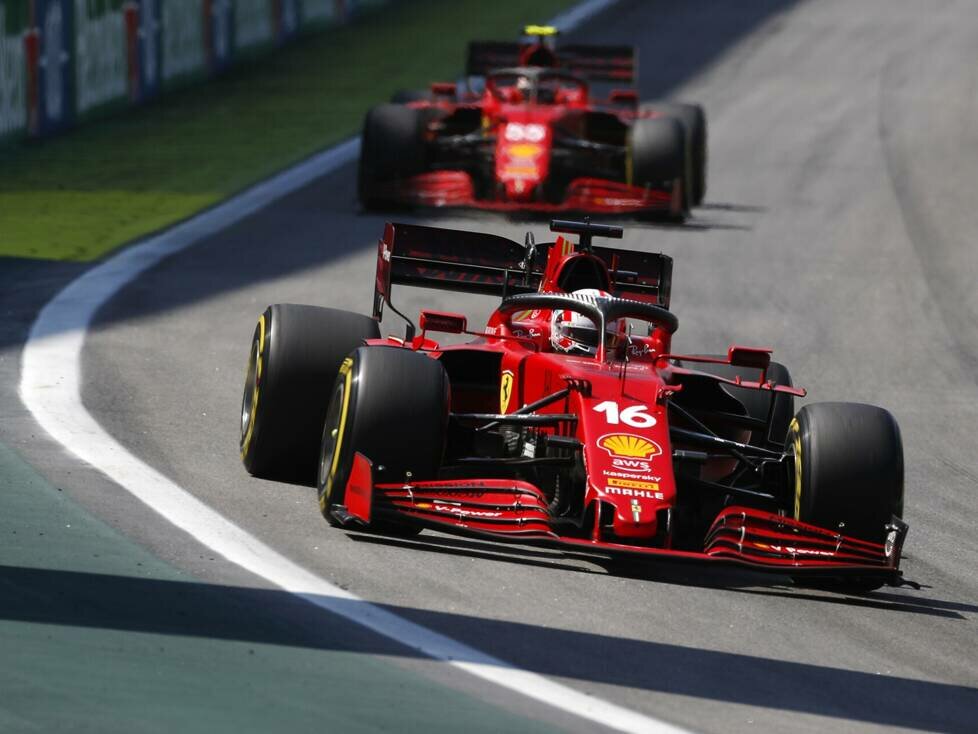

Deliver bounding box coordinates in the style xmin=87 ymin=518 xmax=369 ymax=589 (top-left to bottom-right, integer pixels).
xmin=373 ymin=222 xmax=672 ymax=319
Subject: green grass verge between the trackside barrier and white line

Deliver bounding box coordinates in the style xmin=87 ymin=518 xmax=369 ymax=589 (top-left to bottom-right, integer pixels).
xmin=0 ymin=0 xmax=574 ymax=261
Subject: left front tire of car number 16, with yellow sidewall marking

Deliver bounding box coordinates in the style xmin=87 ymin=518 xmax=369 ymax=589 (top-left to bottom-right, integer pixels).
xmin=317 ymin=347 xmax=449 ymax=533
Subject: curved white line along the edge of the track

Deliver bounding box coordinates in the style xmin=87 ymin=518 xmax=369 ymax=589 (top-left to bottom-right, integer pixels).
xmin=20 ymin=0 xmax=684 ymax=734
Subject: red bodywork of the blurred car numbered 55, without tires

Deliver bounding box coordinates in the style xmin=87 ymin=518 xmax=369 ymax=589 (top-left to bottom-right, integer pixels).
xmin=364 ymin=42 xmax=684 ymax=216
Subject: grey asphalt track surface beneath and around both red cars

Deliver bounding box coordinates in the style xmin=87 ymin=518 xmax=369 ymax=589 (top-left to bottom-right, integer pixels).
xmin=7 ymin=0 xmax=978 ymax=732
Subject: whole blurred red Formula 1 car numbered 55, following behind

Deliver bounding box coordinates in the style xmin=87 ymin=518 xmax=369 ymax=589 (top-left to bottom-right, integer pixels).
xmin=358 ymin=27 xmax=706 ymax=217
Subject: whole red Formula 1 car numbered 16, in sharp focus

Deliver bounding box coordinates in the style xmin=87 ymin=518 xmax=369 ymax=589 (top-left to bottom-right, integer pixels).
xmin=241 ymin=222 xmax=907 ymax=589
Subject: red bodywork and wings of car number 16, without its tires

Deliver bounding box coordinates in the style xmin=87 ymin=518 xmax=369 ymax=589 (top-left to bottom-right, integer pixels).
xmin=337 ymin=224 xmax=906 ymax=579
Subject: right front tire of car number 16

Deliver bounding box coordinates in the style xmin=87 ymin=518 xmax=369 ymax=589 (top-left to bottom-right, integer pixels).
xmin=785 ymin=403 xmax=903 ymax=543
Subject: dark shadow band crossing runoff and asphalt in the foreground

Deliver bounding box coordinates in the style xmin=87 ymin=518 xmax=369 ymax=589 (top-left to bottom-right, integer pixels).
xmin=0 ymin=566 xmax=978 ymax=734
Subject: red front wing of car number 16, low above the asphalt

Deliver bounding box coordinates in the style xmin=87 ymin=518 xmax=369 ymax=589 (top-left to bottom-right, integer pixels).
xmin=333 ymin=453 xmax=907 ymax=581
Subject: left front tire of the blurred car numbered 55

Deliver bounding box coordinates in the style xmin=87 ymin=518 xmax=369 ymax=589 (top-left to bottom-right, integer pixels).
xmin=357 ymin=104 xmax=428 ymax=209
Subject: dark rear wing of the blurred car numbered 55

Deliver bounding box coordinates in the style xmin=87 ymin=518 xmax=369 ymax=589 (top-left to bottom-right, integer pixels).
xmin=465 ymin=41 xmax=638 ymax=85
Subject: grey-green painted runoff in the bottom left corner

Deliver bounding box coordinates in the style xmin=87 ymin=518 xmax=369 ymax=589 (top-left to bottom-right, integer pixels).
xmin=0 ymin=444 xmax=553 ymax=734
